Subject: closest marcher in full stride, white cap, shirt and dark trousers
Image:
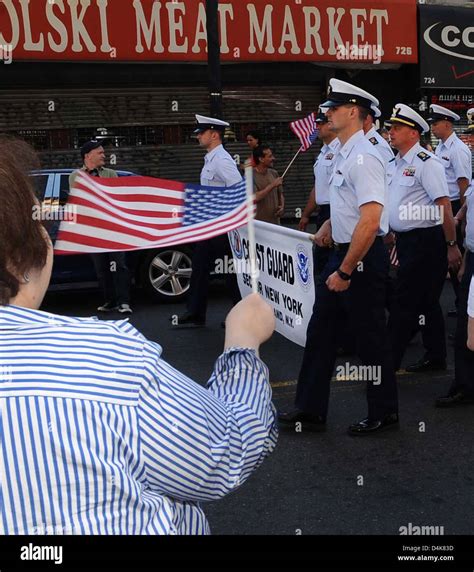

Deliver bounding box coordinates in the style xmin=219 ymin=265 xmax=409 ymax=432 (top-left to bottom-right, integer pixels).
xmin=279 ymin=79 xmax=398 ymax=435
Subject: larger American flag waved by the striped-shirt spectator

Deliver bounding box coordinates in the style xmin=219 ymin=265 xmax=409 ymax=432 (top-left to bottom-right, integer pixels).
xmin=54 ymin=172 xmax=247 ymax=254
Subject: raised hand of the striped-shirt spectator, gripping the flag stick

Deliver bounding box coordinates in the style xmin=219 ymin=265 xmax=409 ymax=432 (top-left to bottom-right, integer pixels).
xmin=224 ymin=294 xmax=275 ymax=350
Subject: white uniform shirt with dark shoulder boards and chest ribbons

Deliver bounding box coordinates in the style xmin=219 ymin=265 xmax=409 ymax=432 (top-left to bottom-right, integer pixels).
xmin=387 ymin=143 xmax=449 ymax=232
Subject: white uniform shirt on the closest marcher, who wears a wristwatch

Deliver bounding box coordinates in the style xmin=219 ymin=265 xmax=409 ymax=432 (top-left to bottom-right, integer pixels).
xmin=329 ymin=129 xmax=388 ymax=243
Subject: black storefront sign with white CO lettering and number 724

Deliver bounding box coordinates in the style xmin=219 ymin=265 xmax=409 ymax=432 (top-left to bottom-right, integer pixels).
xmin=420 ymin=5 xmax=474 ymax=89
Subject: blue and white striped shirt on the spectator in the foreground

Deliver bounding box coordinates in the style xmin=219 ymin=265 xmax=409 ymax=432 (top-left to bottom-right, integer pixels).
xmin=0 ymin=306 xmax=277 ymax=534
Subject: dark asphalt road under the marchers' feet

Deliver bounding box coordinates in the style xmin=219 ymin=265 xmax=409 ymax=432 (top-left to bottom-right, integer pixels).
xmin=43 ymin=283 xmax=474 ymax=535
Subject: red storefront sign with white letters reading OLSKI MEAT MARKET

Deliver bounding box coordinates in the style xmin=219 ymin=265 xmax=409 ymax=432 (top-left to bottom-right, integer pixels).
xmin=0 ymin=0 xmax=418 ymax=63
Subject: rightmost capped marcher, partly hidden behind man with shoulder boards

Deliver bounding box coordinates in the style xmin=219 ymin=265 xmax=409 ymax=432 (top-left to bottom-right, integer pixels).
xmin=428 ymin=104 xmax=472 ymax=316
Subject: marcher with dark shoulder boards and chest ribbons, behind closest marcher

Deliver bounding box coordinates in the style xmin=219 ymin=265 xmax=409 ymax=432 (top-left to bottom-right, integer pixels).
xmin=387 ymin=103 xmax=461 ymax=371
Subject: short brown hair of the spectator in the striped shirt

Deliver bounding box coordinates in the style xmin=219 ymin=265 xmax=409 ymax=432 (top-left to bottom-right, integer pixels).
xmin=0 ymin=135 xmax=48 ymax=306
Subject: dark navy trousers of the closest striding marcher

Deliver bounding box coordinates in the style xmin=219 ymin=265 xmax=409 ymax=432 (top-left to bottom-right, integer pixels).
xmin=295 ymin=238 xmax=398 ymax=419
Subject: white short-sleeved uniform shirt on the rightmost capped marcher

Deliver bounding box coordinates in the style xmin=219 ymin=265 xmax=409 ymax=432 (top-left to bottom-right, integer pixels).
xmin=435 ymin=133 xmax=472 ymax=201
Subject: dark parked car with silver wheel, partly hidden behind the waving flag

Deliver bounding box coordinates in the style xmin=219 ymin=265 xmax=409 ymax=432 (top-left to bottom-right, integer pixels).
xmin=30 ymin=169 xmax=191 ymax=302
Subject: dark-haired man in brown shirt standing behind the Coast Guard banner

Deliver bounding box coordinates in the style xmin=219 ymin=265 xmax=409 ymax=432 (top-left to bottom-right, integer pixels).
xmin=252 ymin=145 xmax=285 ymax=224
